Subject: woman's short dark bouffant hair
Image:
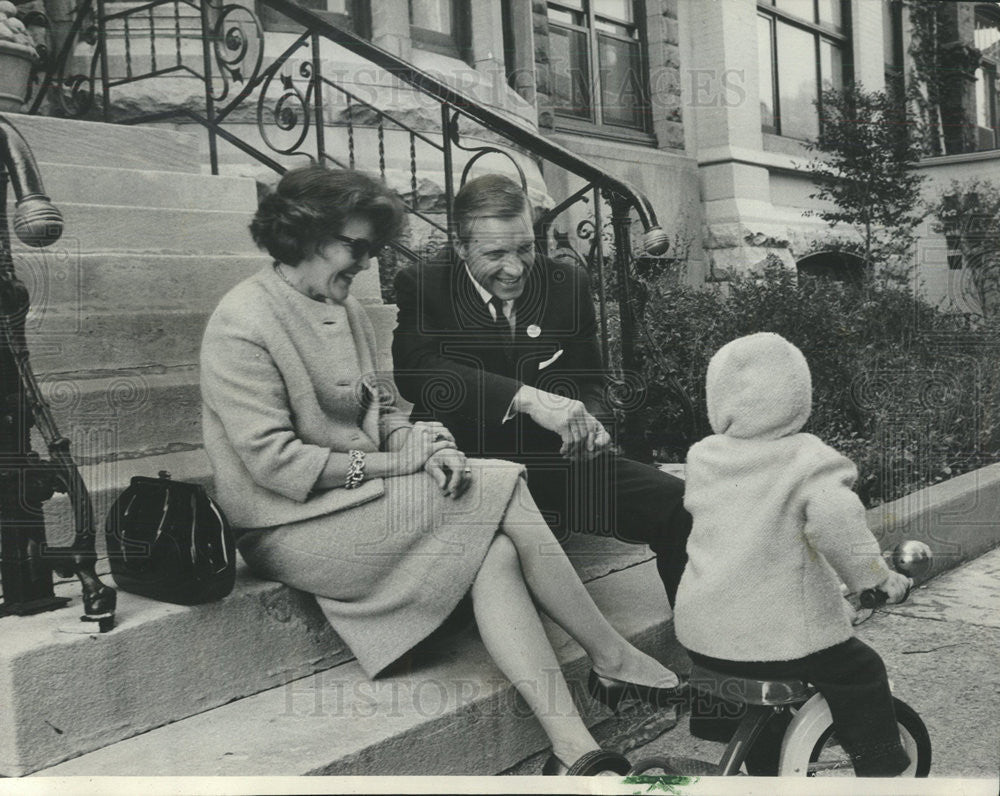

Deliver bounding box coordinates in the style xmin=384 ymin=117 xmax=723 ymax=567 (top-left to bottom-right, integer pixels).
xmin=250 ymin=164 xmax=403 ymax=266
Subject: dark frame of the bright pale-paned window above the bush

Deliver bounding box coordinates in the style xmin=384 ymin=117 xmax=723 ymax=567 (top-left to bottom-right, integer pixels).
xmin=755 ymin=0 xmax=854 ymax=141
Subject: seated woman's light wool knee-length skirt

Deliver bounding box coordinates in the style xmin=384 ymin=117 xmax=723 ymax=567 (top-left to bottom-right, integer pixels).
xmin=238 ymin=459 xmax=528 ymax=677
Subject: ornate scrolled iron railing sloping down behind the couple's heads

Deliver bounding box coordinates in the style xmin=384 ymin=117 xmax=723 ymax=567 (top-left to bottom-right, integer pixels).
xmin=31 ymin=0 xmax=693 ymax=455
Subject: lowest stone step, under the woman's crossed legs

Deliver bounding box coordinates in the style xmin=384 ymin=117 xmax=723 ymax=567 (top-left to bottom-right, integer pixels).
xmin=33 ymin=561 xmax=685 ymax=776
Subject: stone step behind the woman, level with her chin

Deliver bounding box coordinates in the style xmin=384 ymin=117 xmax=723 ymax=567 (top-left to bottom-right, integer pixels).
xmin=14 ymin=252 xmax=381 ymax=314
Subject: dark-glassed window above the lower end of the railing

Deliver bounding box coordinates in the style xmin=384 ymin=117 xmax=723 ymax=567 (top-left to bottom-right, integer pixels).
xmin=547 ymin=0 xmax=649 ymax=135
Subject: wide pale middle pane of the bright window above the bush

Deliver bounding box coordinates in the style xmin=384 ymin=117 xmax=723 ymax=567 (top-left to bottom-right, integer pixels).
xmin=777 ymin=22 xmax=819 ymax=138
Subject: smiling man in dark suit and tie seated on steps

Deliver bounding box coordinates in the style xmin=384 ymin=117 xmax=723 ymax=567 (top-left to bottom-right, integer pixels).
xmin=392 ymin=175 xmax=691 ymax=604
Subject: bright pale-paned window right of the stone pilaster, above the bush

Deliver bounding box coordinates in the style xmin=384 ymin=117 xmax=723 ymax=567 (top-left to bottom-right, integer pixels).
xmin=757 ymin=0 xmax=850 ymax=139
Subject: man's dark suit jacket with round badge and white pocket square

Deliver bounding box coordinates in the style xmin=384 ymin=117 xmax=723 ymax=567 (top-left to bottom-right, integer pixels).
xmin=392 ymin=255 xmax=608 ymax=458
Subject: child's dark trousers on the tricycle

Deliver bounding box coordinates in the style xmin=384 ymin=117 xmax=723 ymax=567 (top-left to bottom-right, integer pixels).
xmin=689 ymin=638 xmax=910 ymax=777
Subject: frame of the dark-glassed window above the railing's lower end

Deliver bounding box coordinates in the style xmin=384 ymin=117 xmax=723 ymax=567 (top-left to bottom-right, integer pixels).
xmin=545 ymin=0 xmax=656 ymax=146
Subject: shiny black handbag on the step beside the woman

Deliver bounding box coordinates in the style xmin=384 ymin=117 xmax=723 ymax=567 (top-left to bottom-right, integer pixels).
xmin=104 ymin=471 xmax=236 ymax=605
